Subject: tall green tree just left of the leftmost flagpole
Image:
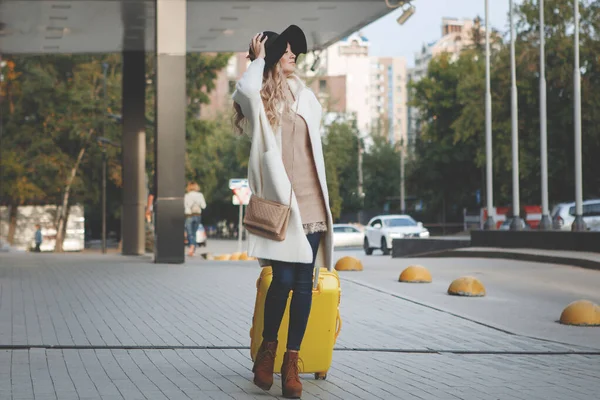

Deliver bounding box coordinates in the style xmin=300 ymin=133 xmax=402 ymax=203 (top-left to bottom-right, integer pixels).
xmin=407 ymin=52 xmax=481 ymax=219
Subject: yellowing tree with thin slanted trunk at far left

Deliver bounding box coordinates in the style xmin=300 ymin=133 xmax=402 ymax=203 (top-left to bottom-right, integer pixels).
xmin=2 ymin=55 xmax=122 ymax=247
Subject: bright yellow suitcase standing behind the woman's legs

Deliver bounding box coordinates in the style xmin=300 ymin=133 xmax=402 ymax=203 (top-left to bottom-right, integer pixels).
xmin=250 ymin=267 xmax=342 ymax=379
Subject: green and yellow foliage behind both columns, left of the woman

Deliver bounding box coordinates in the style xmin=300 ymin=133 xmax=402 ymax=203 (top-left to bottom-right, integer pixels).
xmin=0 ymin=54 xmax=233 ymax=236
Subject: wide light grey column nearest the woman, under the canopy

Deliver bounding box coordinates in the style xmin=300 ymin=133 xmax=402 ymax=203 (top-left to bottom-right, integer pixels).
xmin=154 ymin=0 xmax=187 ymax=264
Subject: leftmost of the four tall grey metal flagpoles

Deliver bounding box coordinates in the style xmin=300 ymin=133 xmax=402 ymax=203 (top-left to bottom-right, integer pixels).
xmin=484 ymin=0 xmax=496 ymax=230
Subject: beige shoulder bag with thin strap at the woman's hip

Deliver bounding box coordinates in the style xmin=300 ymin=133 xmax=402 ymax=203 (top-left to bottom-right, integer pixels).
xmin=244 ymin=90 xmax=300 ymax=242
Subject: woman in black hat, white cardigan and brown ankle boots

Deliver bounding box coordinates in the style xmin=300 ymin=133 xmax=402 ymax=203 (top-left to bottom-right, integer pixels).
xmin=233 ymin=25 xmax=333 ymax=398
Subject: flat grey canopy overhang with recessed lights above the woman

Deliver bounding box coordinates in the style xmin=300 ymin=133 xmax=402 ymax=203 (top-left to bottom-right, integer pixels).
xmin=0 ymin=0 xmax=392 ymax=54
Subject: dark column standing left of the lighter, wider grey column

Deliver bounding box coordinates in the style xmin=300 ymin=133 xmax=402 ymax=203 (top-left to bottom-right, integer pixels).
xmin=121 ymin=2 xmax=146 ymax=255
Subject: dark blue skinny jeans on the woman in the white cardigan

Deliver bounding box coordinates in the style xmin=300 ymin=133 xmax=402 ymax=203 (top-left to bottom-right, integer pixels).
xmin=263 ymin=232 xmax=321 ymax=351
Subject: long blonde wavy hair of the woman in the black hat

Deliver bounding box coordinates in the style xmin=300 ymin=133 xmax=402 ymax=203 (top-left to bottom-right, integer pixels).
xmin=233 ymin=50 xmax=290 ymax=133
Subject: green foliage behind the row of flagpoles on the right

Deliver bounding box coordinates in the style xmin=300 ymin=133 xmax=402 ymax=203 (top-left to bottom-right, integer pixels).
xmin=407 ymin=0 xmax=600 ymax=220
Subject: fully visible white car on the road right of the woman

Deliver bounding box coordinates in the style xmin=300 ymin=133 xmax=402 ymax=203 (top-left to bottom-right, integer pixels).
xmin=363 ymin=215 xmax=429 ymax=256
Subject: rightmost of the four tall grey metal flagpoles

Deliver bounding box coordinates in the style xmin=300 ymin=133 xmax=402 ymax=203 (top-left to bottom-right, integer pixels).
xmin=571 ymin=0 xmax=586 ymax=232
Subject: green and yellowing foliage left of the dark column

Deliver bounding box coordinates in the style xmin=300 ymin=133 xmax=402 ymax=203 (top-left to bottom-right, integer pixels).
xmin=1 ymin=55 xmax=120 ymax=209
